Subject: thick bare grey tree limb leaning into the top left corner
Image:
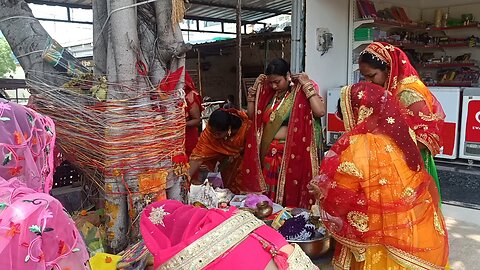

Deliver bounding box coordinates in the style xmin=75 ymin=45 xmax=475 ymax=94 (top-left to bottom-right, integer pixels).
xmin=0 ymin=0 xmax=69 ymax=86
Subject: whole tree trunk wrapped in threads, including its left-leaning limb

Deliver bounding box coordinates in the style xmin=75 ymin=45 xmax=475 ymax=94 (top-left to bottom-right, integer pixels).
xmin=0 ymin=0 xmax=191 ymax=252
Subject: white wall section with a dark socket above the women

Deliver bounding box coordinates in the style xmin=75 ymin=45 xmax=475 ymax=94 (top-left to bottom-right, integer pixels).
xmin=305 ymin=0 xmax=349 ymax=98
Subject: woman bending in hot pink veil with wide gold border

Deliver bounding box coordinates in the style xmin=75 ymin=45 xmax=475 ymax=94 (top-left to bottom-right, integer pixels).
xmin=140 ymin=200 xmax=318 ymax=270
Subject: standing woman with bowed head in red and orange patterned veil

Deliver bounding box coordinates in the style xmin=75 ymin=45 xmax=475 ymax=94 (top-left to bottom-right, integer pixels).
xmin=359 ymin=42 xmax=445 ymax=198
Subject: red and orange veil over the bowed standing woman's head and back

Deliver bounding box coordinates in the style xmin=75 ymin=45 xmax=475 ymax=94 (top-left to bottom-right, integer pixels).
xmin=362 ymin=42 xmax=445 ymax=156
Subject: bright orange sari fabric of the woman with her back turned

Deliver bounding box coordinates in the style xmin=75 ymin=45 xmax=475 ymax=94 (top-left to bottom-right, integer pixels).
xmin=333 ymin=134 xmax=448 ymax=269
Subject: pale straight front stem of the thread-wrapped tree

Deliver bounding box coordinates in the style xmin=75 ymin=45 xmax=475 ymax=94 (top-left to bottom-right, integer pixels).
xmin=105 ymin=0 xmax=141 ymax=252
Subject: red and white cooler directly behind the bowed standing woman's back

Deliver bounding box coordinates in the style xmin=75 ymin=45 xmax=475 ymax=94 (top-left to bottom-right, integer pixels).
xmin=429 ymin=87 xmax=462 ymax=159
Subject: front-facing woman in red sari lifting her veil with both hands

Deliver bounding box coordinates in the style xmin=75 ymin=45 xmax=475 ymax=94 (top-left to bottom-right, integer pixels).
xmin=241 ymin=59 xmax=325 ymax=207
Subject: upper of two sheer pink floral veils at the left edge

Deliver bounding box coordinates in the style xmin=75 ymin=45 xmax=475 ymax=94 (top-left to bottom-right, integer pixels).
xmin=0 ymin=99 xmax=55 ymax=193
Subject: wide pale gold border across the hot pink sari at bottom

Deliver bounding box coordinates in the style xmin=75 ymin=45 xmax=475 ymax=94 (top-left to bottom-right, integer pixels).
xmin=158 ymin=211 xmax=265 ymax=270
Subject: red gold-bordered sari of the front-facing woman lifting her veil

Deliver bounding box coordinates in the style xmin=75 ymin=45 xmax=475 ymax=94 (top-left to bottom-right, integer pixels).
xmin=241 ymin=81 xmax=320 ymax=207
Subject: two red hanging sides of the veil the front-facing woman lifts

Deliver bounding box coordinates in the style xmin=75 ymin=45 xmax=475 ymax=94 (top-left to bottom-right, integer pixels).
xmin=241 ymin=79 xmax=318 ymax=207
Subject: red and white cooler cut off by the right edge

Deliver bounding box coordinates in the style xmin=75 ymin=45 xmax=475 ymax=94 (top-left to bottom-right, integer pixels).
xmin=459 ymin=88 xmax=480 ymax=160
